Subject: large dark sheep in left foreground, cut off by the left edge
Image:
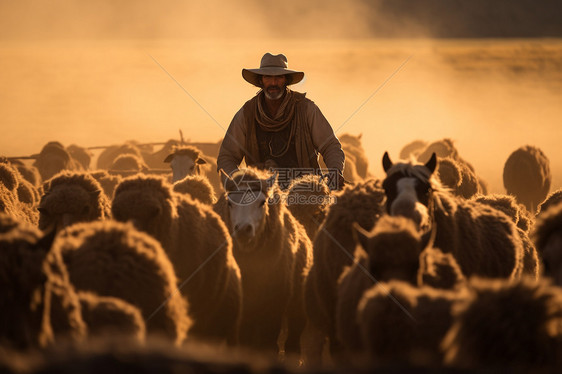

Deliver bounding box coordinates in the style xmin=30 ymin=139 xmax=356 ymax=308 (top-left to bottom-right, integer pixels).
xmin=0 ymin=213 xmax=87 ymax=350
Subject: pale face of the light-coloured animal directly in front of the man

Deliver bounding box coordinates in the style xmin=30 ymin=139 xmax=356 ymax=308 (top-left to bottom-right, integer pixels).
xmin=228 ymin=190 xmax=267 ymax=241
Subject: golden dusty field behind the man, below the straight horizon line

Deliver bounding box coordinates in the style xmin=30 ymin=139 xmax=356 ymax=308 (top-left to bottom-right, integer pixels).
xmin=0 ymin=39 xmax=562 ymax=192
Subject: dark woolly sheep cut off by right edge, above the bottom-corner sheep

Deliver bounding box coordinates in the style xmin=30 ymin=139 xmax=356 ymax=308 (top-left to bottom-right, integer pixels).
xmin=531 ymin=204 xmax=562 ymax=287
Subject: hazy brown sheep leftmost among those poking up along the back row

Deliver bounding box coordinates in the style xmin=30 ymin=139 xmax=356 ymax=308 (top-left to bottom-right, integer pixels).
xmin=33 ymin=142 xmax=82 ymax=181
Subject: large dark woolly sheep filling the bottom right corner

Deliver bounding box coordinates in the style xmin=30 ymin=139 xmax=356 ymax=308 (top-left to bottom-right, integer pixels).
xmin=441 ymin=278 xmax=562 ymax=371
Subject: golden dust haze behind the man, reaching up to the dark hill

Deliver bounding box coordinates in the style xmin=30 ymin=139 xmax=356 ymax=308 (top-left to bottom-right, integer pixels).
xmin=0 ymin=0 xmax=562 ymax=192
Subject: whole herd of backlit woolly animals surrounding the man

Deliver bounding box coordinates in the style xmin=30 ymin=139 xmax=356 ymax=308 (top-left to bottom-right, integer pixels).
xmin=0 ymin=135 xmax=562 ymax=373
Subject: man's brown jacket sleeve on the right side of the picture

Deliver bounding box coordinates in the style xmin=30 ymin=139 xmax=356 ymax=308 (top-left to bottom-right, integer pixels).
xmin=308 ymin=102 xmax=345 ymax=173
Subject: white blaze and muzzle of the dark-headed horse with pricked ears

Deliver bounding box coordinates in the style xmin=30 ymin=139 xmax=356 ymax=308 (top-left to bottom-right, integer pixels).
xmin=390 ymin=178 xmax=429 ymax=229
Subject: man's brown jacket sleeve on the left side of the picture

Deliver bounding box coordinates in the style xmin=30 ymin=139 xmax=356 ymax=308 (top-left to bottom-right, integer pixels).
xmin=217 ymin=109 xmax=246 ymax=175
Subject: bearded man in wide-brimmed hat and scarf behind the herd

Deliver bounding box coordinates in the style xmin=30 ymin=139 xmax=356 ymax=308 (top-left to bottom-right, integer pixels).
xmin=217 ymin=53 xmax=345 ymax=189
